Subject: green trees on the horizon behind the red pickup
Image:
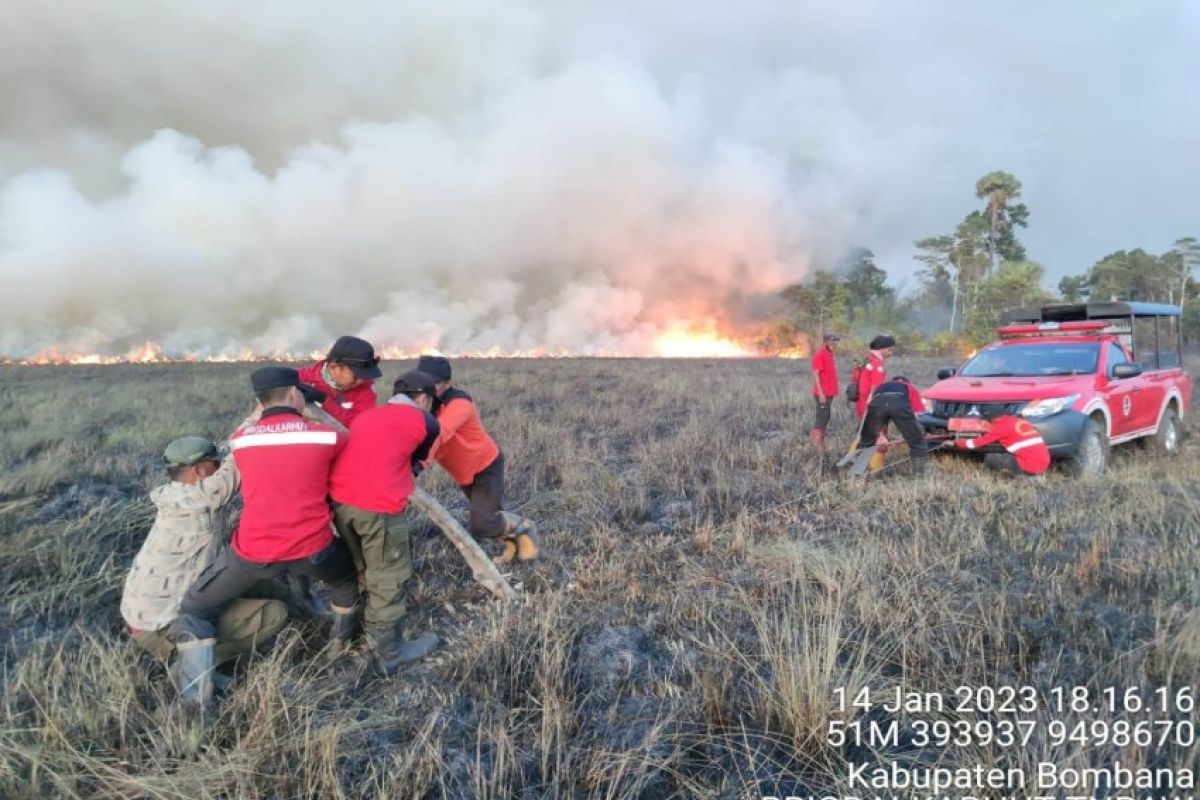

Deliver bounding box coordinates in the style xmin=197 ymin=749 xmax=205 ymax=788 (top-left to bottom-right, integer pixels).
xmin=762 ymin=170 xmax=1200 ymax=353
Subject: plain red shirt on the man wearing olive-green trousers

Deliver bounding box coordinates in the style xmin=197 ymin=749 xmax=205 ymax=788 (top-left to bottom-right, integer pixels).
xmin=329 ymin=395 xmax=436 ymax=513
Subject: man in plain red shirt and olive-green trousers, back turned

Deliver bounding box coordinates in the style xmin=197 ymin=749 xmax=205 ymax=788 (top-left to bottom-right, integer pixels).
xmin=330 ymin=372 xmax=439 ymax=675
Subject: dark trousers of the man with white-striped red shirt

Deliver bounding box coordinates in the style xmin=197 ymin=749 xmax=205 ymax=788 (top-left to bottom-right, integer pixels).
xmin=173 ymin=539 xmax=359 ymax=642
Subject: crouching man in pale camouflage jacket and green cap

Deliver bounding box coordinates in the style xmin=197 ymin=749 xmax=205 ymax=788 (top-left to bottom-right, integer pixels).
xmin=121 ymin=437 xmax=288 ymax=681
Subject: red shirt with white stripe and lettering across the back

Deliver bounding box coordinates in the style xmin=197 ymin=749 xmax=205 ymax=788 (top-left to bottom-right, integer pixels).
xmin=229 ymin=408 xmax=346 ymax=564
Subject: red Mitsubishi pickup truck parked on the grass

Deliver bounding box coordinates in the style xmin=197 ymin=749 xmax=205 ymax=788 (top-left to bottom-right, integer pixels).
xmin=922 ymin=302 xmax=1192 ymax=475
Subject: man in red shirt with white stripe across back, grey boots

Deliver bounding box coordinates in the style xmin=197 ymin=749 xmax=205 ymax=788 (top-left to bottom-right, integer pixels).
xmin=172 ymin=367 xmax=359 ymax=706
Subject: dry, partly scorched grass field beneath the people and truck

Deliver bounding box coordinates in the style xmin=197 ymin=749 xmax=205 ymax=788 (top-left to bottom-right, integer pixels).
xmin=0 ymin=359 xmax=1200 ymax=799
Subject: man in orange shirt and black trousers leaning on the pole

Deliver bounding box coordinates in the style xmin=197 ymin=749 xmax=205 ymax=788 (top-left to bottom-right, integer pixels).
xmin=416 ymin=355 xmax=539 ymax=564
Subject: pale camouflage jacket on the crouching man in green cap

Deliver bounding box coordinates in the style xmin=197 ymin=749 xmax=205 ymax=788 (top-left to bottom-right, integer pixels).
xmin=121 ymin=458 xmax=241 ymax=631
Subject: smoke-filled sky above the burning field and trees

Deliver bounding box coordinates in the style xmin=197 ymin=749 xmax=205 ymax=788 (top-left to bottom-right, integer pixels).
xmin=0 ymin=0 xmax=1200 ymax=357
